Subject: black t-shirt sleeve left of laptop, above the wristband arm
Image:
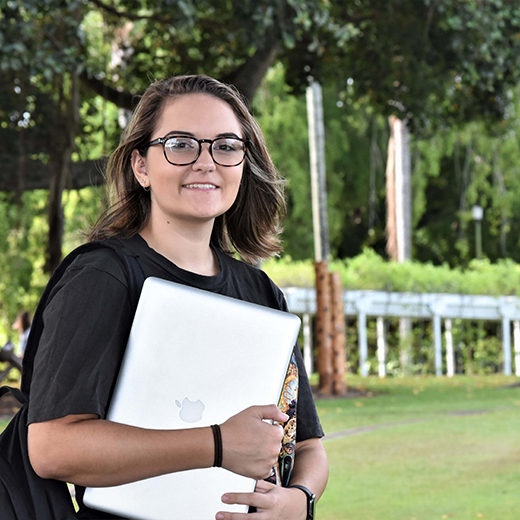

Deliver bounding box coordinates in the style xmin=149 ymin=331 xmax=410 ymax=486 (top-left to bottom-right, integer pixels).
xmin=28 ymin=253 xmax=132 ymax=423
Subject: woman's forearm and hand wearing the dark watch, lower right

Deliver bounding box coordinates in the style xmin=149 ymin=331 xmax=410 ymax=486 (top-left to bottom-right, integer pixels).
xmin=216 ymin=439 xmax=329 ymax=520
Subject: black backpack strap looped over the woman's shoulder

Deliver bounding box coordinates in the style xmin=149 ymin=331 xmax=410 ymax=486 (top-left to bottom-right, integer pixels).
xmin=20 ymin=240 xmax=145 ymax=400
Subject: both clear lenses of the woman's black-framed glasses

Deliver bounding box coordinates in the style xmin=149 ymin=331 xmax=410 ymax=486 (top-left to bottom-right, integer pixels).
xmin=164 ymin=137 xmax=245 ymax=166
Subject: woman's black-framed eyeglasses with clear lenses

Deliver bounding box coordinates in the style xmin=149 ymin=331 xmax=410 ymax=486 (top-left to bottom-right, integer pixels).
xmin=148 ymin=135 xmax=249 ymax=166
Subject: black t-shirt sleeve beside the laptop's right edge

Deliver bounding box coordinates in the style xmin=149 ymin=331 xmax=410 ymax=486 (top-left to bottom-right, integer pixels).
xmin=273 ymin=284 xmax=325 ymax=442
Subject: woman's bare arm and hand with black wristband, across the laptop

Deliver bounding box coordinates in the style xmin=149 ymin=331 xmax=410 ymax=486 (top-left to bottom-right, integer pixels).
xmin=28 ymin=405 xmax=287 ymax=487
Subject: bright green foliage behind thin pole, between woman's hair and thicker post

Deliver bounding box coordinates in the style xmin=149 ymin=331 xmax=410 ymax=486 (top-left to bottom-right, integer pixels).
xmin=254 ymin=66 xmax=388 ymax=259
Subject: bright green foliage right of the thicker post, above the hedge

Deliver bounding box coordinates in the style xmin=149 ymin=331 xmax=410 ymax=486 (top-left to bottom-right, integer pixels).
xmin=412 ymin=105 xmax=520 ymax=266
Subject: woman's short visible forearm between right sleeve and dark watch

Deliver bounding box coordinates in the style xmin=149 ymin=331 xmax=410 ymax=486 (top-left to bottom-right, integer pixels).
xmin=289 ymin=439 xmax=329 ymax=499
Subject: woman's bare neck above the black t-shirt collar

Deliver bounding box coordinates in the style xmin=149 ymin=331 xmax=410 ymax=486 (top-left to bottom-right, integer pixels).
xmin=140 ymin=215 xmax=220 ymax=276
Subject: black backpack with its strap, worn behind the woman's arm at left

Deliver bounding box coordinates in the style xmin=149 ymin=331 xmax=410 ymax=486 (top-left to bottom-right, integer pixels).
xmin=0 ymin=241 xmax=144 ymax=520
